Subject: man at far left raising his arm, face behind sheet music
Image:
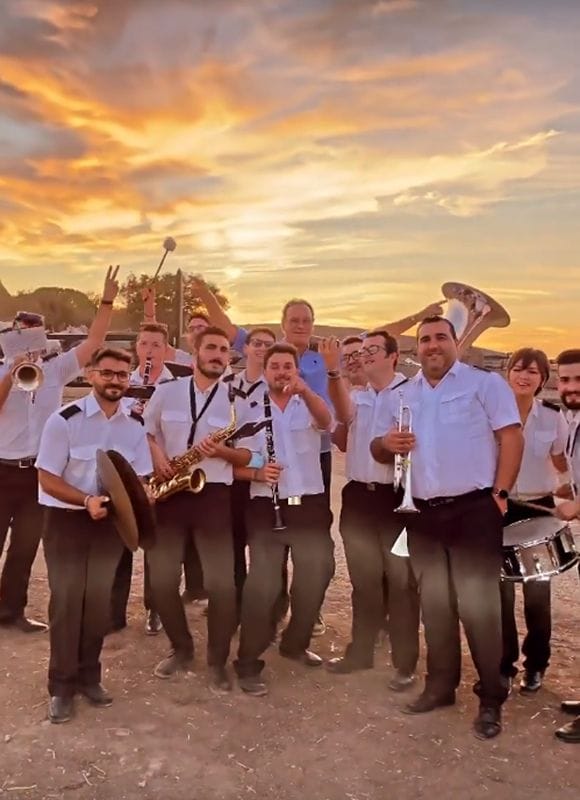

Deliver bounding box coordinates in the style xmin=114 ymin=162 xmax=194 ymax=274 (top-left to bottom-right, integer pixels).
xmin=0 ymin=267 xmax=119 ymax=633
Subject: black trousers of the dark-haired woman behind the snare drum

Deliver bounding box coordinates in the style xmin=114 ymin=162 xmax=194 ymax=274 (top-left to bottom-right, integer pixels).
xmin=500 ymin=495 xmax=555 ymax=678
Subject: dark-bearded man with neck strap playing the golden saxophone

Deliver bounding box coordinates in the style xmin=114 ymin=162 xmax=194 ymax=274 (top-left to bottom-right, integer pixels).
xmin=144 ymin=327 xmax=251 ymax=692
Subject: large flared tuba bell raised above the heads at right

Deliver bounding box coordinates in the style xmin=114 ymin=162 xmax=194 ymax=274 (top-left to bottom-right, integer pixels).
xmin=441 ymin=282 xmax=511 ymax=354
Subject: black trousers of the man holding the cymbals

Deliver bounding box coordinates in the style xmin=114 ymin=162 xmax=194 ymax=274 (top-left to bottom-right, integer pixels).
xmin=43 ymin=508 xmax=123 ymax=697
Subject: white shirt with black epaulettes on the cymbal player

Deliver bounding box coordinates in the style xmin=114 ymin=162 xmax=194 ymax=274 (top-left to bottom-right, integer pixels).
xmin=36 ymin=392 xmax=153 ymax=511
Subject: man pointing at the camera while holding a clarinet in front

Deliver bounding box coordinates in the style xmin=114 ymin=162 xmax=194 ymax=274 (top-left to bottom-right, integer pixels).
xmin=230 ymin=343 xmax=334 ymax=696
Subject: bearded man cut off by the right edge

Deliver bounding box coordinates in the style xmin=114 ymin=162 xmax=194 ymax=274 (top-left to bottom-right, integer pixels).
xmin=556 ymin=349 xmax=580 ymax=743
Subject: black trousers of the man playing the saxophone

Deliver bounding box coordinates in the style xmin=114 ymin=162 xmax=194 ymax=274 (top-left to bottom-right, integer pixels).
xmin=146 ymin=483 xmax=236 ymax=666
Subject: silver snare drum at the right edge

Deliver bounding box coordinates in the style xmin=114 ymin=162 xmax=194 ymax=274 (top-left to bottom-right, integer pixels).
xmin=502 ymin=516 xmax=580 ymax=582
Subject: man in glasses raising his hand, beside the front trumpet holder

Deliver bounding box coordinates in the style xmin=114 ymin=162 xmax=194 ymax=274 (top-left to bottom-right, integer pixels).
xmin=324 ymin=330 xmax=419 ymax=691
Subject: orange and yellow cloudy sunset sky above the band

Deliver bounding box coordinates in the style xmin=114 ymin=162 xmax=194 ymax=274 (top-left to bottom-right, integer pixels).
xmin=0 ymin=0 xmax=580 ymax=354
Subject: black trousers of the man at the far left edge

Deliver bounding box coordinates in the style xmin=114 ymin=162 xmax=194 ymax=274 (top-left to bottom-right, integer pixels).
xmin=0 ymin=464 xmax=42 ymax=622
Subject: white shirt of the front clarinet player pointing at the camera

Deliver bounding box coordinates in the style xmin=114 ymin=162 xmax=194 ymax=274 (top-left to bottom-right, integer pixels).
xmin=245 ymin=393 xmax=324 ymax=500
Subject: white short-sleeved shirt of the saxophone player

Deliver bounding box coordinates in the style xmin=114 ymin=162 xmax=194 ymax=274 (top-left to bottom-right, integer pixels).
xmin=143 ymin=377 xmax=249 ymax=485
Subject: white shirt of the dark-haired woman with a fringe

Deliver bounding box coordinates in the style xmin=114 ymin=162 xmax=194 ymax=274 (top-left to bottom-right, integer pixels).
xmin=510 ymin=400 xmax=568 ymax=500
